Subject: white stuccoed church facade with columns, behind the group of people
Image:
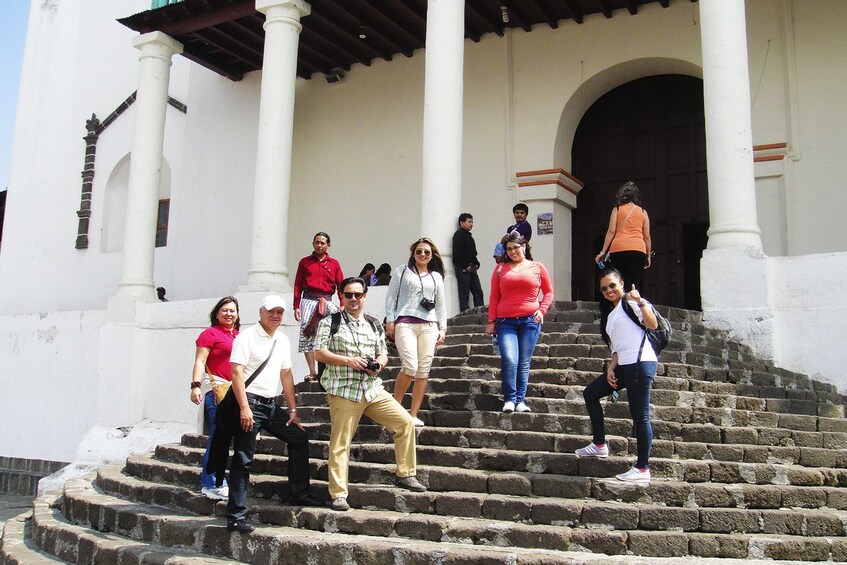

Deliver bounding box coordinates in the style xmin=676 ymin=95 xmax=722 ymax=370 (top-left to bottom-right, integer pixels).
xmin=0 ymin=0 xmax=847 ymax=474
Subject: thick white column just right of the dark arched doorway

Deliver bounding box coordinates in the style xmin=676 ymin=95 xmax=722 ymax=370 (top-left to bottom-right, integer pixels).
xmin=700 ymin=0 xmax=762 ymax=251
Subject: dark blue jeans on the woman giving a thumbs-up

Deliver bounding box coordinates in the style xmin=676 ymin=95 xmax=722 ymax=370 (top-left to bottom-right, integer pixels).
xmin=582 ymin=361 xmax=658 ymax=469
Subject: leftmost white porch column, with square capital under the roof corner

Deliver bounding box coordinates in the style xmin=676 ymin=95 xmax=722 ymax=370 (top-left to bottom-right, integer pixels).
xmin=110 ymin=31 xmax=182 ymax=312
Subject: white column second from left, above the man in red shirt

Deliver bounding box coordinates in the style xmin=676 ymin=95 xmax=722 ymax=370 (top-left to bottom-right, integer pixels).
xmin=239 ymin=0 xmax=311 ymax=292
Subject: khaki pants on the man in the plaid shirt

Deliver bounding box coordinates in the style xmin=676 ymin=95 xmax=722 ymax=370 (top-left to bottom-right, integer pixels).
xmin=327 ymin=391 xmax=416 ymax=500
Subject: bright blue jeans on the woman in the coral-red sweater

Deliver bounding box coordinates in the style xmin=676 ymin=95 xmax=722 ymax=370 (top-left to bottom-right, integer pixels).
xmin=496 ymin=315 xmax=541 ymax=404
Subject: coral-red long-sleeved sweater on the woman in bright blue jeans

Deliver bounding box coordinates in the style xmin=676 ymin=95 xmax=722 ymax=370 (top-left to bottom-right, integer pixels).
xmin=488 ymin=261 xmax=553 ymax=322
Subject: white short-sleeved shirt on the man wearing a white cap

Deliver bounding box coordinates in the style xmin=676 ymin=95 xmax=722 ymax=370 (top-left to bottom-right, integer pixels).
xmin=229 ymin=324 xmax=291 ymax=398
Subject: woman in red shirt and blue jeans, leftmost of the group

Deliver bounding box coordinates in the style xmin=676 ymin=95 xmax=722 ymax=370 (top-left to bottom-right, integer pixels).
xmin=191 ymin=296 xmax=241 ymax=500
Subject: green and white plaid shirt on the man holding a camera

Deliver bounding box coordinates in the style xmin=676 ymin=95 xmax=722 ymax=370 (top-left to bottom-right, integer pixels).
xmin=315 ymin=312 xmax=388 ymax=402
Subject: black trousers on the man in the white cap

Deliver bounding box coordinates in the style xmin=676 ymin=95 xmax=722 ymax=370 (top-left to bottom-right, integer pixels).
xmin=226 ymin=397 xmax=310 ymax=521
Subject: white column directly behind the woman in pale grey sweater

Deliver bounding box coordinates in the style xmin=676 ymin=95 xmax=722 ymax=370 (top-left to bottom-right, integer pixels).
xmin=421 ymin=0 xmax=465 ymax=313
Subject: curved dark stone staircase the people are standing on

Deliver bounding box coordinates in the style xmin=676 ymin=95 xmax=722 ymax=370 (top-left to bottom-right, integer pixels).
xmin=0 ymin=302 xmax=847 ymax=565
